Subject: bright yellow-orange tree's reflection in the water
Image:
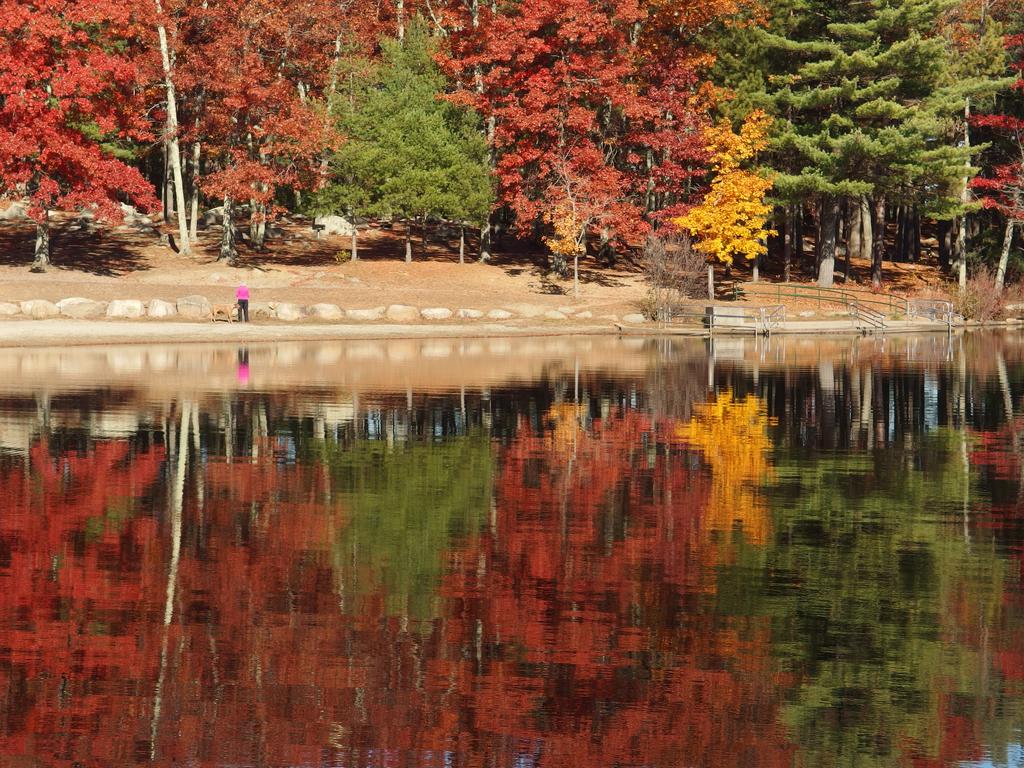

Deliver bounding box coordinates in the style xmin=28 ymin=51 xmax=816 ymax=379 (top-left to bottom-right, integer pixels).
xmin=676 ymin=391 xmax=771 ymax=544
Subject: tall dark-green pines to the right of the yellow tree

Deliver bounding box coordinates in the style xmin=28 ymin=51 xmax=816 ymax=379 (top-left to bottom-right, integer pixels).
xmin=719 ymin=0 xmax=1002 ymax=286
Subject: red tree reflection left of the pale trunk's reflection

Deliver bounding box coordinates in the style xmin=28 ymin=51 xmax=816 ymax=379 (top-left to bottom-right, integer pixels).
xmin=0 ymin=442 xmax=163 ymax=765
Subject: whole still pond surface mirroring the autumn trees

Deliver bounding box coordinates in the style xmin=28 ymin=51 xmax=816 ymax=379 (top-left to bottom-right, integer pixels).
xmin=0 ymin=335 xmax=1024 ymax=768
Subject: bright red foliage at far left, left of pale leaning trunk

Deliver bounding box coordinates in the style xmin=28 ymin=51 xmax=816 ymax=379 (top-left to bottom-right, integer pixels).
xmin=0 ymin=0 xmax=156 ymax=221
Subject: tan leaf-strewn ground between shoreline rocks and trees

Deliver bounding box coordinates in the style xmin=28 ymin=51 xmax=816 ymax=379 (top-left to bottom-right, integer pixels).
xmin=0 ymin=208 xmax=958 ymax=317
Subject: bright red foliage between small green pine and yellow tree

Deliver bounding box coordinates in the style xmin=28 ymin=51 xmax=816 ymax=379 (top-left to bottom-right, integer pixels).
xmin=443 ymin=0 xmax=736 ymax=244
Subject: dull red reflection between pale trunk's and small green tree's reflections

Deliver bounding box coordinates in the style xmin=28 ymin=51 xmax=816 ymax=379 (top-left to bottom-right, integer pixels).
xmin=151 ymin=455 xmax=340 ymax=765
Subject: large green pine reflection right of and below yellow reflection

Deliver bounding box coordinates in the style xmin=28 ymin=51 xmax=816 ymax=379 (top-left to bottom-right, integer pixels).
xmin=720 ymin=432 xmax=1010 ymax=766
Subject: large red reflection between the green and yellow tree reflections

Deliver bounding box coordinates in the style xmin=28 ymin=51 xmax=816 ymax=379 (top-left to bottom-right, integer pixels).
xmin=403 ymin=412 xmax=792 ymax=766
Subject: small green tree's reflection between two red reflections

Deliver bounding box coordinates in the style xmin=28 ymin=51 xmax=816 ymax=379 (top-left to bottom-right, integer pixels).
xmin=322 ymin=432 xmax=494 ymax=620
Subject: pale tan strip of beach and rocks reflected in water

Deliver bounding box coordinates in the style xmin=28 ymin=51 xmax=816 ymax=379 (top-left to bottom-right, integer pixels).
xmin=0 ymin=333 xmax=1024 ymax=399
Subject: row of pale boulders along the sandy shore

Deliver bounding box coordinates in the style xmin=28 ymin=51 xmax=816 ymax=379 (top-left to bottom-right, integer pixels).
xmin=0 ymin=295 xmax=644 ymax=323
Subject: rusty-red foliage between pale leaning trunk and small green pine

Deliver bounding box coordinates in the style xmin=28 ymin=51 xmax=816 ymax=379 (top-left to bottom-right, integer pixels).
xmin=158 ymin=0 xmax=356 ymax=214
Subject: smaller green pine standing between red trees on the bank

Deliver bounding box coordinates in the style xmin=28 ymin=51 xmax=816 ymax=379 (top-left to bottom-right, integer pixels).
xmin=312 ymin=20 xmax=494 ymax=261
